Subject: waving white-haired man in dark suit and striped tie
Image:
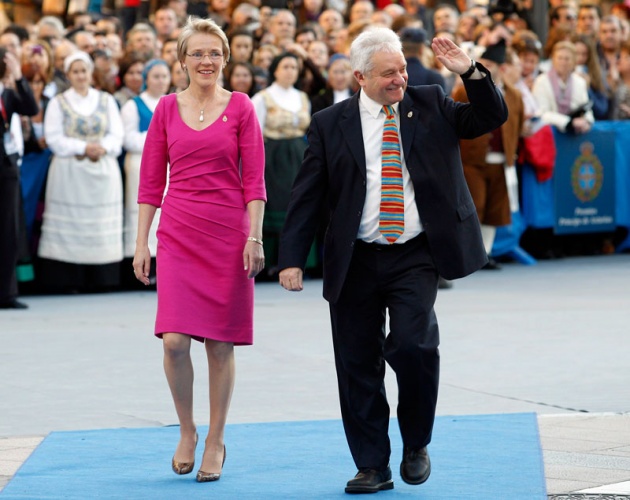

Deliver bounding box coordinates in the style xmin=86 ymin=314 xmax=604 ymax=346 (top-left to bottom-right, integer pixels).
xmin=279 ymin=28 xmax=507 ymax=493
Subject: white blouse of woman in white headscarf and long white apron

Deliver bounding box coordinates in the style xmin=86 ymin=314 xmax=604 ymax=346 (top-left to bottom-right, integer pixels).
xmin=44 ymin=88 xmax=124 ymax=156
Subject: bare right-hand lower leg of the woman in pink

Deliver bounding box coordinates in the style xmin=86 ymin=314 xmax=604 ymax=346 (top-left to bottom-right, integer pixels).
xmin=200 ymin=339 xmax=234 ymax=473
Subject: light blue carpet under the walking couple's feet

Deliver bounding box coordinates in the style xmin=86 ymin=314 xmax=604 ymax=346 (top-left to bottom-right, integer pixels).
xmin=0 ymin=413 xmax=546 ymax=500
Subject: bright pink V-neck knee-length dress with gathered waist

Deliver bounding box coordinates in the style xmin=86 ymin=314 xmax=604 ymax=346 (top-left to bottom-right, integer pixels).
xmin=138 ymin=92 xmax=266 ymax=345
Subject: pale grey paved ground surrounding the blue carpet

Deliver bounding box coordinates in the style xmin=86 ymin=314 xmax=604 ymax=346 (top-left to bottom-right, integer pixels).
xmin=0 ymin=254 xmax=630 ymax=499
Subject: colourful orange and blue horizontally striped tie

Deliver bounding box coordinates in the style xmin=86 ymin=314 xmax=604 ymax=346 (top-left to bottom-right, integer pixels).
xmin=378 ymin=106 xmax=405 ymax=243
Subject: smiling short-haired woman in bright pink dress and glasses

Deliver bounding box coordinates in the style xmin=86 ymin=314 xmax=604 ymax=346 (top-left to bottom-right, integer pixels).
xmin=133 ymin=18 xmax=266 ymax=482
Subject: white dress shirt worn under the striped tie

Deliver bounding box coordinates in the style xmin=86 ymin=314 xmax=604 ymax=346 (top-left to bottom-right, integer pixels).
xmin=357 ymin=91 xmax=422 ymax=245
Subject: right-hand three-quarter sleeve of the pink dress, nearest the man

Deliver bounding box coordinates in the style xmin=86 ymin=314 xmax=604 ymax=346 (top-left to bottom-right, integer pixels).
xmin=238 ymin=94 xmax=267 ymax=203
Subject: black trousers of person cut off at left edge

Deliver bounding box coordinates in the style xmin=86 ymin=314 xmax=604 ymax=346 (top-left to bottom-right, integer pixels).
xmin=0 ymin=160 xmax=20 ymax=302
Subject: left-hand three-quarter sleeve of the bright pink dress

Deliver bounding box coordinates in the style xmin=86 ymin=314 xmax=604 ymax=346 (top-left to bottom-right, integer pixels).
xmin=138 ymin=98 xmax=168 ymax=207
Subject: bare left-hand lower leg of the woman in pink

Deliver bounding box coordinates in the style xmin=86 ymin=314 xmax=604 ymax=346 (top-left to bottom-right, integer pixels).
xmin=162 ymin=333 xmax=197 ymax=463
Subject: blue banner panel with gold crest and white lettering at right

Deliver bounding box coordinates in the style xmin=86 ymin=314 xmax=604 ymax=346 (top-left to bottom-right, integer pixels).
xmin=553 ymin=130 xmax=615 ymax=234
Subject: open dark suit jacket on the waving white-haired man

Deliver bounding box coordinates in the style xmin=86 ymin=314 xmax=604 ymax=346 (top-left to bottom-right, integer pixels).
xmin=279 ymin=65 xmax=507 ymax=303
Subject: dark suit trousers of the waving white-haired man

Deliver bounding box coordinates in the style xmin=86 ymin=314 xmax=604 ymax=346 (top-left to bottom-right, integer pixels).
xmin=330 ymin=234 xmax=439 ymax=469
